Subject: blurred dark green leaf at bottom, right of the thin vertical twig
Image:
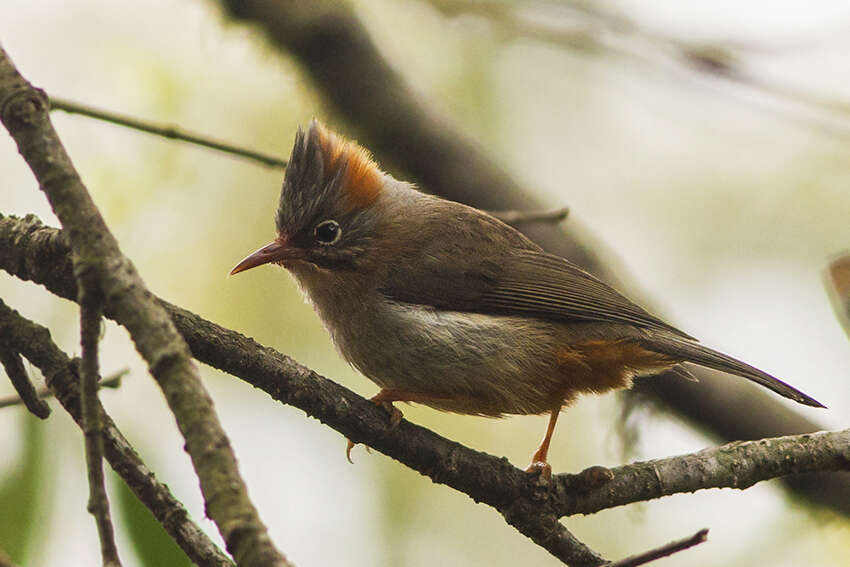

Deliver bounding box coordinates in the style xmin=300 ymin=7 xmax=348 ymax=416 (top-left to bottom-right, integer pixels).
xmin=111 ymin=473 xmax=192 ymax=567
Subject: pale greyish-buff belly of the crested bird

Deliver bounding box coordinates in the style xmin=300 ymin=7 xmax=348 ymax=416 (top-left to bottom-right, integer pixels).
xmin=329 ymin=302 xmax=567 ymax=416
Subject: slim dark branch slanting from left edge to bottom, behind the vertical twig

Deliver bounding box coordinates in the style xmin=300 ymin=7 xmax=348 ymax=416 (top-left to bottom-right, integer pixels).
xmin=0 ymin=300 xmax=233 ymax=567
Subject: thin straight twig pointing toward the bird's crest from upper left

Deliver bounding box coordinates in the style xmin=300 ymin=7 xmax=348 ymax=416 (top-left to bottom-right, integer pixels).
xmin=50 ymin=96 xmax=286 ymax=169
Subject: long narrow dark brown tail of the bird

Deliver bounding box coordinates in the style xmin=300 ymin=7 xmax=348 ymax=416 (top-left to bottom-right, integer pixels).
xmin=644 ymin=337 xmax=826 ymax=408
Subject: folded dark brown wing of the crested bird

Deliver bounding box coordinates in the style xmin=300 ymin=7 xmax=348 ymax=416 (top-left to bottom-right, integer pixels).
xmin=381 ymin=245 xmax=693 ymax=340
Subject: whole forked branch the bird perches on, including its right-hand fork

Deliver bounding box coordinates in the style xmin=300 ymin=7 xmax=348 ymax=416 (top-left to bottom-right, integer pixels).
xmin=0 ymin=216 xmax=850 ymax=564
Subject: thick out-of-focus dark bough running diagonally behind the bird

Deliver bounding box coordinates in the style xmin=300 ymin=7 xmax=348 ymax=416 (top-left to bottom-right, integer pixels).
xmin=219 ymin=0 xmax=850 ymax=514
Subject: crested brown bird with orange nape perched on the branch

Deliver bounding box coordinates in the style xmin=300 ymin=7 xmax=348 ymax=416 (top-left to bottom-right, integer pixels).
xmin=230 ymin=120 xmax=823 ymax=474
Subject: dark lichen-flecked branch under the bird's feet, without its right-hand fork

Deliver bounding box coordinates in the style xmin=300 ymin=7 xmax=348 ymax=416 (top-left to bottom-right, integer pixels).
xmin=0 ymin=215 xmax=604 ymax=565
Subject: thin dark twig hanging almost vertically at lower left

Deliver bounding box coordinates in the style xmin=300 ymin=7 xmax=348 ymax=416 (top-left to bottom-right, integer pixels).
xmin=77 ymin=272 xmax=121 ymax=567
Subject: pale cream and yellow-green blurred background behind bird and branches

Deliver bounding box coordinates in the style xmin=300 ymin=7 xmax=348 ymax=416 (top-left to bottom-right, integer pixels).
xmin=0 ymin=0 xmax=850 ymax=566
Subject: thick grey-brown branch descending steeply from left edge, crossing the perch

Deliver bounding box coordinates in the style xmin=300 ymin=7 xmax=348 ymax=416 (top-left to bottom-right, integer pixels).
xmin=0 ymin=44 xmax=288 ymax=566
